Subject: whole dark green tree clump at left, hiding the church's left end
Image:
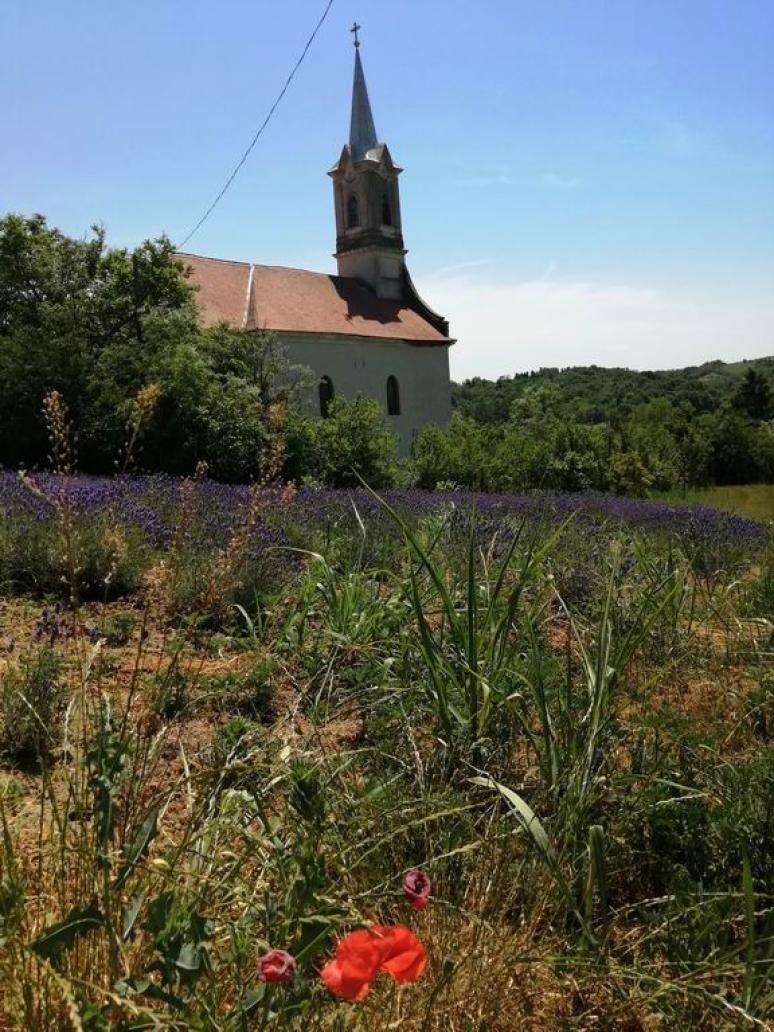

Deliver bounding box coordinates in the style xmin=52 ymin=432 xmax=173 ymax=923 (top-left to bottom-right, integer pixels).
xmin=0 ymin=216 xmax=315 ymax=480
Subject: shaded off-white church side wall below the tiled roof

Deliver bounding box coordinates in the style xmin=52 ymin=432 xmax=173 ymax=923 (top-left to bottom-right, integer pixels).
xmin=278 ymin=332 xmax=451 ymax=455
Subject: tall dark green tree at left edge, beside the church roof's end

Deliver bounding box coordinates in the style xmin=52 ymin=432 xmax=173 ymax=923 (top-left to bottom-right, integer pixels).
xmin=0 ymin=215 xmax=197 ymax=470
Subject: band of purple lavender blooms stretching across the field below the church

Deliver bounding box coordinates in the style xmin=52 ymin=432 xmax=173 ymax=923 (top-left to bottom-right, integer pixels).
xmin=0 ymin=470 xmax=767 ymax=548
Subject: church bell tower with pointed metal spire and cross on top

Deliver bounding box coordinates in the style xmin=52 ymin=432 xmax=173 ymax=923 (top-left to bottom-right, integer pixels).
xmin=328 ymin=24 xmax=406 ymax=300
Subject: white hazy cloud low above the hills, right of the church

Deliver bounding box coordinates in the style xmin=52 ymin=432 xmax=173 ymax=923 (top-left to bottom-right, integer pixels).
xmin=419 ymin=272 xmax=774 ymax=379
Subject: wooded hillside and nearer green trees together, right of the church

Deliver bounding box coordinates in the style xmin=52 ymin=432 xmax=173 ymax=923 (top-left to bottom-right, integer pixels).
xmin=412 ymin=357 xmax=774 ymax=494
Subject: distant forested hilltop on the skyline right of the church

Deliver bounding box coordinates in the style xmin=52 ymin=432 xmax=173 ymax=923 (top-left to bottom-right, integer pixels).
xmin=452 ymin=356 xmax=774 ymax=425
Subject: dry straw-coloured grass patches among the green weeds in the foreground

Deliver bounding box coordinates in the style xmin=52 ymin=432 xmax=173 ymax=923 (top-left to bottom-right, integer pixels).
xmin=0 ymin=536 xmax=770 ymax=1032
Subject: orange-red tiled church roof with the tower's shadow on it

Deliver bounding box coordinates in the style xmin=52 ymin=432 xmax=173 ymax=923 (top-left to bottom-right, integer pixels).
xmin=178 ymin=254 xmax=448 ymax=344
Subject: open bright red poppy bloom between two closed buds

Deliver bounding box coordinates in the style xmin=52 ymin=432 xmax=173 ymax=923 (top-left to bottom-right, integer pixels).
xmin=321 ymin=925 xmax=427 ymax=1000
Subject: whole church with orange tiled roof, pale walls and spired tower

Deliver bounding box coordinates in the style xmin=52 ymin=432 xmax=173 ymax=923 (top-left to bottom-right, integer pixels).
xmin=178 ymin=32 xmax=454 ymax=455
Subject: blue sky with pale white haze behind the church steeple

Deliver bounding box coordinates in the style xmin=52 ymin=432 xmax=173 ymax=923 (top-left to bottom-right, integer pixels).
xmin=0 ymin=0 xmax=774 ymax=378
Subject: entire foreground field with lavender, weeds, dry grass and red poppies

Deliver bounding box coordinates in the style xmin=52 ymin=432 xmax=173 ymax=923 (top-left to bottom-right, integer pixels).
xmin=0 ymin=472 xmax=774 ymax=1032
